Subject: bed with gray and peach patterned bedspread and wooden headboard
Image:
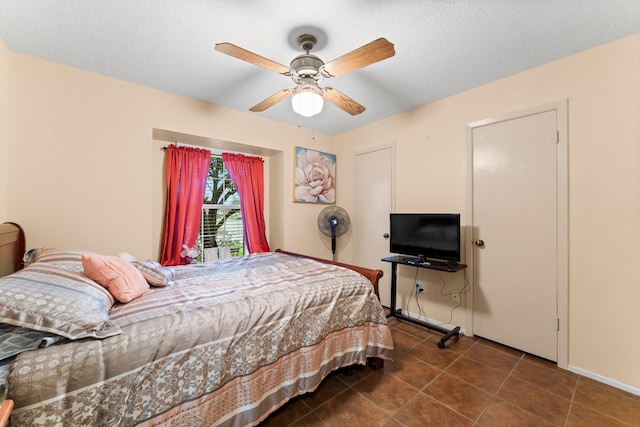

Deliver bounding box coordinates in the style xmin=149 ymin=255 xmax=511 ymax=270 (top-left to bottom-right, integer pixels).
xmin=0 ymin=224 xmax=393 ymax=427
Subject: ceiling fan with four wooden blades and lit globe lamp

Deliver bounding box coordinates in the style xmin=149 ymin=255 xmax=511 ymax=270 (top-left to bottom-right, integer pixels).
xmin=215 ymin=34 xmax=396 ymax=117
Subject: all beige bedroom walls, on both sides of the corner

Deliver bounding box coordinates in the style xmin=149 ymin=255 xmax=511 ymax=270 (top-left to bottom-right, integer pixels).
xmin=0 ymin=35 xmax=640 ymax=390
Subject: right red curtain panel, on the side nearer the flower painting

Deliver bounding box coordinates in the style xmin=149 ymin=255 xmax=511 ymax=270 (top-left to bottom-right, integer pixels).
xmin=222 ymin=153 xmax=270 ymax=253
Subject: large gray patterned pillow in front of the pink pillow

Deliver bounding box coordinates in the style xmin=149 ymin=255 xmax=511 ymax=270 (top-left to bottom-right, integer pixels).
xmin=0 ymin=262 xmax=121 ymax=340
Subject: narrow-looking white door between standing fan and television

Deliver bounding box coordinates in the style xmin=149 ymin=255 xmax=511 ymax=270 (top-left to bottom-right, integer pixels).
xmin=352 ymin=146 xmax=393 ymax=307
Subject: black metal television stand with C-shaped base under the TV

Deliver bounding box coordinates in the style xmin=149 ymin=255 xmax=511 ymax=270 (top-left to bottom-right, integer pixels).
xmin=382 ymin=255 xmax=467 ymax=348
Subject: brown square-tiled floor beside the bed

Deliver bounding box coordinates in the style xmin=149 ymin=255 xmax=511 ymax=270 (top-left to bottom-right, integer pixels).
xmin=260 ymin=318 xmax=640 ymax=427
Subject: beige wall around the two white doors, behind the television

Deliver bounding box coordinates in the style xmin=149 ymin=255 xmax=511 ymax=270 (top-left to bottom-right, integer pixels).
xmin=336 ymin=34 xmax=640 ymax=391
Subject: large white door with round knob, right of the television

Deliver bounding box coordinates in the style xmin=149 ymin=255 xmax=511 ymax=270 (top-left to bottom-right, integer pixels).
xmin=472 ymin=110 xmax=558 ymax=361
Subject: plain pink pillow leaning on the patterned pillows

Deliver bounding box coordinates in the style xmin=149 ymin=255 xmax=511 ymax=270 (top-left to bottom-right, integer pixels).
xmin=82 ymin=254 xmax=149 ymax=303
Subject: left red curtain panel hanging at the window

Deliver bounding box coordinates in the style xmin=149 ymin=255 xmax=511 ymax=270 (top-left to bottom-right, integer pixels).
xmin=160 ymin=145 xmax=211 ymax=265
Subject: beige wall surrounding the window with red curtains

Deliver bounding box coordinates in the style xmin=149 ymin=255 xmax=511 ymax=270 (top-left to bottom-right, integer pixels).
xmin=7 ymin=52 xmax=330 ymax=257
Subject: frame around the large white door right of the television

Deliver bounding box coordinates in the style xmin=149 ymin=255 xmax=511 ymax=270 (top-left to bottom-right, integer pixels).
xmin=465 ymin=99 xmax=570 ymax=369
